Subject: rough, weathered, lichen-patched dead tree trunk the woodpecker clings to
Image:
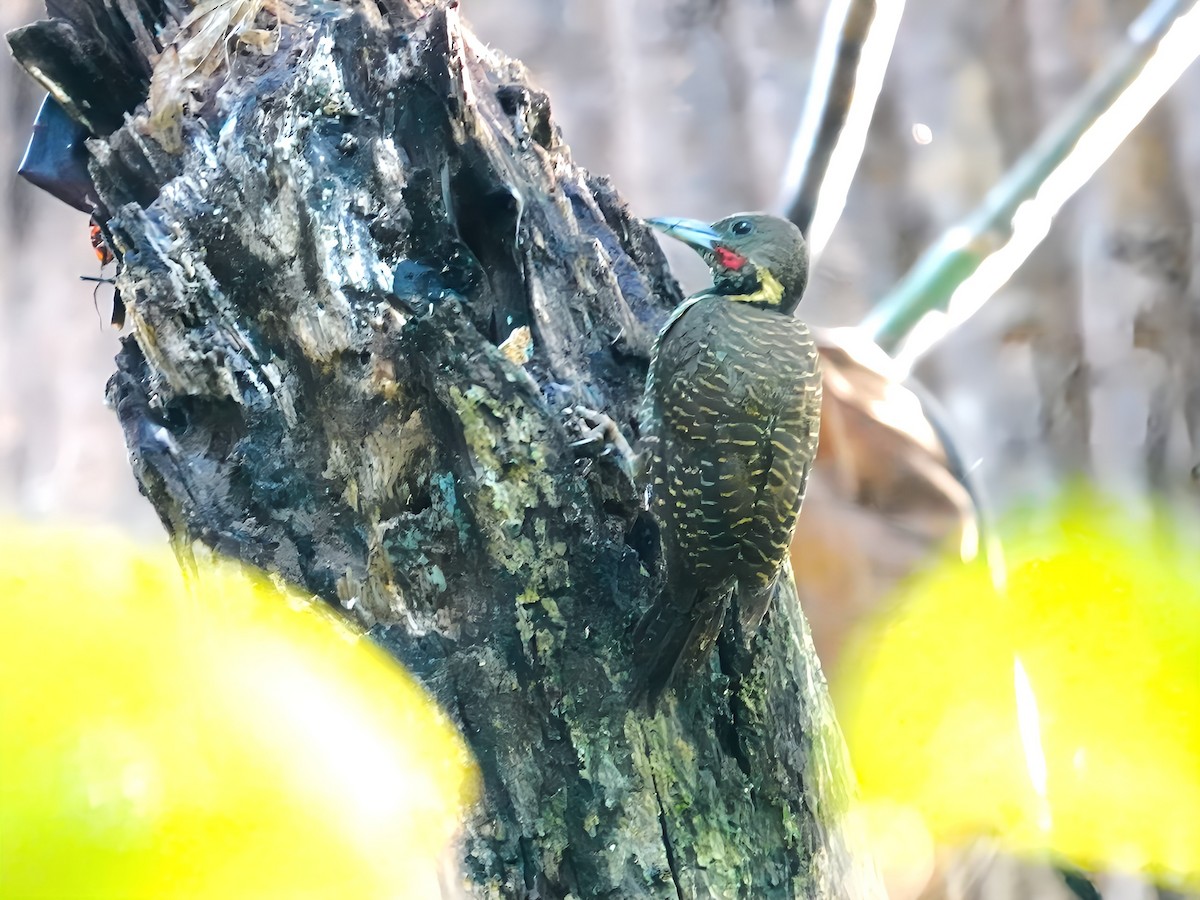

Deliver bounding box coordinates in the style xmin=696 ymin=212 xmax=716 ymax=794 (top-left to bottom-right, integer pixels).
xmin=10 ymin=0 xmax=878 ymax=898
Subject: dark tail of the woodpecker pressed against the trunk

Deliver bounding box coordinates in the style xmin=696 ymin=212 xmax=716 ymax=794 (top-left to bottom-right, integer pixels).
xmin=632 ymin=582 xmax=733 ymax=707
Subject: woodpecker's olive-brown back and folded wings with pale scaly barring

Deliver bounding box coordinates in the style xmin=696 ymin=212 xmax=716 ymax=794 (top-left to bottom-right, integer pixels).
xmin=647 ymin=296 xmax=821 ymax=600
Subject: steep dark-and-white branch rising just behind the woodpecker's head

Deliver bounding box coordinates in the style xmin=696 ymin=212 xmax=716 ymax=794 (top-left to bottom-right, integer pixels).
xmin=784 ymin=0 xmax=904 ymax=256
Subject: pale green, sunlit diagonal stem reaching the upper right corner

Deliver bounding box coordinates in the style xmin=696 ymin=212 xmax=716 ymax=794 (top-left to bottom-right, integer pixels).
xmin=862 ymin=0 xmax=1200 ymax=362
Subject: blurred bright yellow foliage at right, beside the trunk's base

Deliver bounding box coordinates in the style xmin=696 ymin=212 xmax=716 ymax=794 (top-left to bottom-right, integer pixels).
xmin=834 ymin=494 xmax=1200 ymax=884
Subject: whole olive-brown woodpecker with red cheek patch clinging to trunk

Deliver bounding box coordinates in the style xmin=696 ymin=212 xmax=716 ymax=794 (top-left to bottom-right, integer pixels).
xmin=634 ymin=214 xmax=821 ymax=703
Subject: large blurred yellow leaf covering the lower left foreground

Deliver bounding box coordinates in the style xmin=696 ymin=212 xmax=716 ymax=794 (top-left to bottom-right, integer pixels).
xmin=0 ymin=526 xmax=478 ymax=900
